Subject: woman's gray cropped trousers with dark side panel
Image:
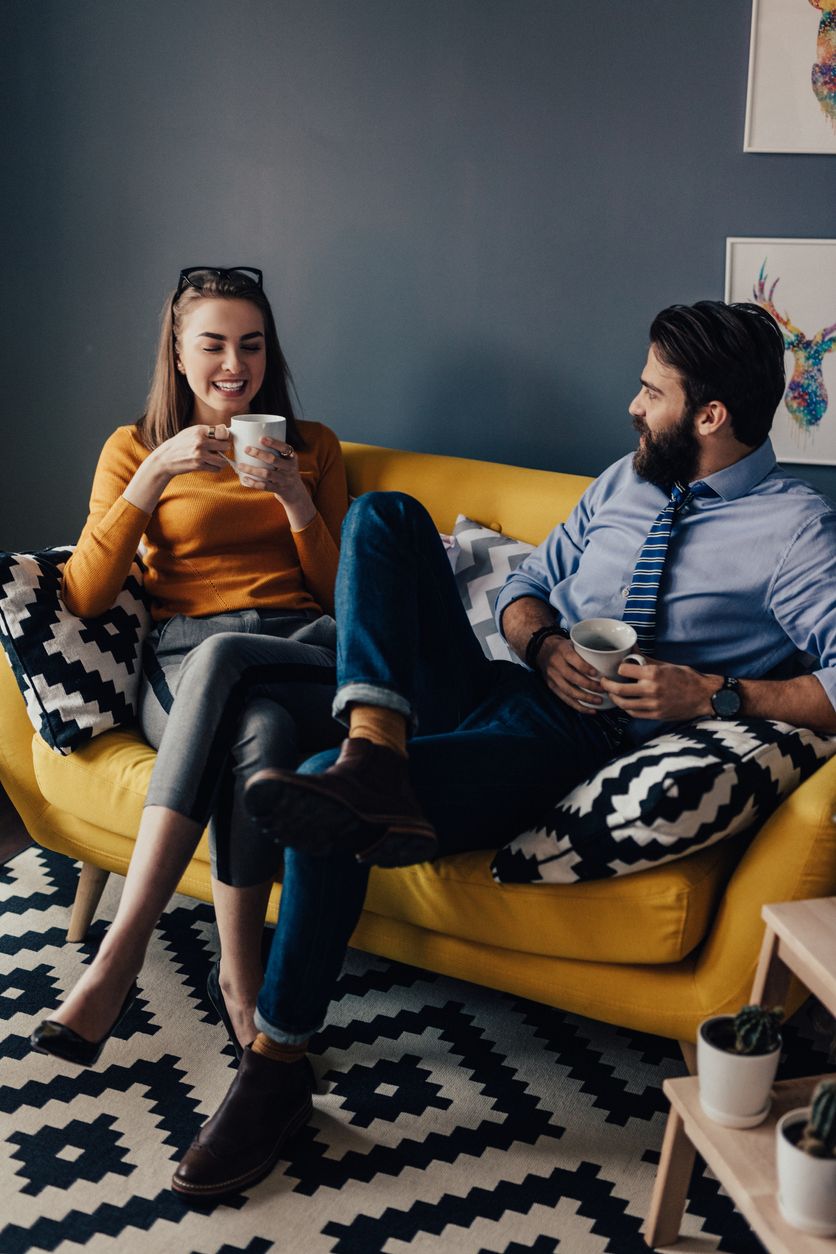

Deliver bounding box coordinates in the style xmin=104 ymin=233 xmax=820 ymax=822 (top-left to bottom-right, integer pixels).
xmin=139 ymin=609 xmax=345 ymax=887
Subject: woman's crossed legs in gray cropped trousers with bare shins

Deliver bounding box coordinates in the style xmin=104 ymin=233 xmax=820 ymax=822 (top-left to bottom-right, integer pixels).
xmin=32 ymin=624 xmax=337 ymax=1046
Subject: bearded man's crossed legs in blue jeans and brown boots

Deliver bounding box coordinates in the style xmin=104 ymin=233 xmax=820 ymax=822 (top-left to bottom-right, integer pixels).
xmin=172 ymin=493 xmax=614 ymax=1198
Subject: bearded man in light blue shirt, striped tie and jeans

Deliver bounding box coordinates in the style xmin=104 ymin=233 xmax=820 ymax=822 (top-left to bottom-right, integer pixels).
xmin=167 ymin=301 xmax=836 ymax=1198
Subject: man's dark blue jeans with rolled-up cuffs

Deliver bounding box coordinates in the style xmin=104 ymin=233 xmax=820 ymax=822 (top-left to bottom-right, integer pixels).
xmin=256 ymin=492 xmax=620 ymax=1043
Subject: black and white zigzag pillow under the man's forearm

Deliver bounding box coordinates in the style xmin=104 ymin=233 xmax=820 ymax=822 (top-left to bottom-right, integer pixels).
xmin=491 ymin=719 xmax=836 ymax=884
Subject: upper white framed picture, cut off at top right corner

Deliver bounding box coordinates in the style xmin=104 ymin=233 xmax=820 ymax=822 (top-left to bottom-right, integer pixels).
xmin=743 ymin=0 xmax=836 ymax=153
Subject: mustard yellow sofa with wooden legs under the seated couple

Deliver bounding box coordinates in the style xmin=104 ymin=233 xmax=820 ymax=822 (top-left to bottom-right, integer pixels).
xmin=0 ymin=444 xmax=836 ymax=1046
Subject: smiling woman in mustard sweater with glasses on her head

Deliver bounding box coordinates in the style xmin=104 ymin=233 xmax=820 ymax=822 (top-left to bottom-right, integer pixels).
xmin=33 ymin=267 xmax=347 ymax=1065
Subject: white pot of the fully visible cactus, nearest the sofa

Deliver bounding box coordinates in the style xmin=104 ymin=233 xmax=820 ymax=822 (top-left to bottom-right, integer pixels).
xmin=697 ymin=1014 xmax=781 ymax=1127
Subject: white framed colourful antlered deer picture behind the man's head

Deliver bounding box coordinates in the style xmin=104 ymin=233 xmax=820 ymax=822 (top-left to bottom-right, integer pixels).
xmin=726 ymin=237 xmax=836 ymax=465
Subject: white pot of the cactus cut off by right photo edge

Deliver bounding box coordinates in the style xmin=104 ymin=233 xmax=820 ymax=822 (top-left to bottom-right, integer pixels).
xmin=775 ymin=1106 xmax=836 ymax=1236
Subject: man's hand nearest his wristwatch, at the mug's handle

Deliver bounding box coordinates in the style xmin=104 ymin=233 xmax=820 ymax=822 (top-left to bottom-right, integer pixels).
xmin=600 ymin=660 xmax=723 ymax=721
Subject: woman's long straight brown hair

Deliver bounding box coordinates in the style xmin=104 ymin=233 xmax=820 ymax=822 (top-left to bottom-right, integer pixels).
xmin=135 ymin=271 xmax=306 ymax=449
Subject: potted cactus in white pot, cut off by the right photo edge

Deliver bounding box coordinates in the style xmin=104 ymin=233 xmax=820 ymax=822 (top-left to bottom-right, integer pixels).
xmin=776 ymin=1078 xmax=836 ymax=1236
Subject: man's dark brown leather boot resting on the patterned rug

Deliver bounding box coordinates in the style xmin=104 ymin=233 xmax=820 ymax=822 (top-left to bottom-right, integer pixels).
xmin=172 ymin=1046 xmax=313 ymax=1200
